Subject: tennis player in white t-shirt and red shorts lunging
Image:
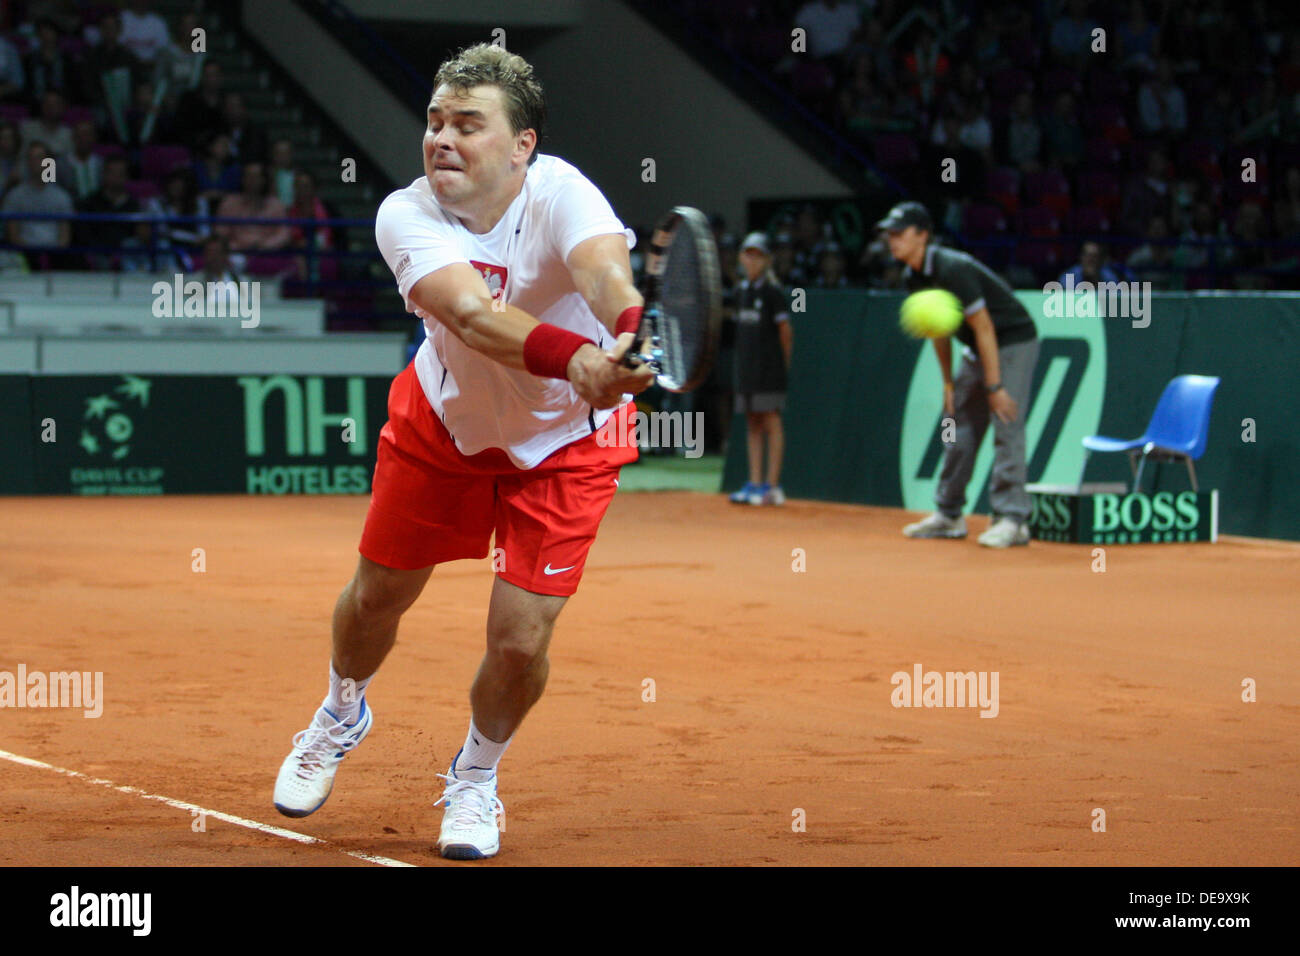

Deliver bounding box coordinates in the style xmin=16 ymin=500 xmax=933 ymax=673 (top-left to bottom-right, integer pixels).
xmin=274 ymin=44 xmax=654 ymax=860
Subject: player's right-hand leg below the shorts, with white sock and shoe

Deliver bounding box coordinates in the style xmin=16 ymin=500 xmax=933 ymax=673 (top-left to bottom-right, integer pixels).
xmin=438 ymin=578 xmax=568 ymax=860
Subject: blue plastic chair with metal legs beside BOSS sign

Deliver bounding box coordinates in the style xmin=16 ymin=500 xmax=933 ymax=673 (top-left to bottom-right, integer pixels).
xmin=1079 ymin=375 xmax=1219 ymax=492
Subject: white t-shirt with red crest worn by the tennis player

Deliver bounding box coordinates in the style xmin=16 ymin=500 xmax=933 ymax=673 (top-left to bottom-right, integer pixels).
xmin=374 ymin=156 xmax=636 ymax=468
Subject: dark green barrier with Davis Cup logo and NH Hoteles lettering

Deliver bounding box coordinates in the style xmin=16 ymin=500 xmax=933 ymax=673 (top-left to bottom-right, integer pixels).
xmin=0 ymin=375 xmax=391 ymax=494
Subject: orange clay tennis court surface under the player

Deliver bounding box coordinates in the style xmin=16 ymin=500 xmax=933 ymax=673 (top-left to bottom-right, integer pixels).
xmin=0 ymin=493 xmax=1300 ymax=866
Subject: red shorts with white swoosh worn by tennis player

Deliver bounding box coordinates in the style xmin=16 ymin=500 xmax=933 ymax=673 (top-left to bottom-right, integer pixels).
xmin=358 ymin=365 xmax=637 ymax=597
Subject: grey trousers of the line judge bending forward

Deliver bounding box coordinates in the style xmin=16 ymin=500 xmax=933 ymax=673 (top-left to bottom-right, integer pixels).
xmin=935 ymin=338 xmax=1039 ymax=522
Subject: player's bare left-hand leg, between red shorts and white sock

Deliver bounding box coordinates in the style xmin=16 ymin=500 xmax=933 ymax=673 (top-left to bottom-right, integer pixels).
xmin=333 ymin=557 xmax=433 ymax=682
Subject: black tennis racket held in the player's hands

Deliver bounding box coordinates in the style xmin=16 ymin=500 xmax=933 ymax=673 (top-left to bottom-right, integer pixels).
xmin=623 ymin=206 xmax=723 ymax=392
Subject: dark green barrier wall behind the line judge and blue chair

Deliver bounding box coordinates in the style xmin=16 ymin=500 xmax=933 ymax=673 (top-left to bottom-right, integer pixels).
xmin=724 ymin=289 xmax=1300 ymax=540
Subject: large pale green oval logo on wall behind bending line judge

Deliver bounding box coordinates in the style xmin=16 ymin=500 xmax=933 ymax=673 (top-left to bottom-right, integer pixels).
xmin=898 ymin=293 xmax=1106 ymax=511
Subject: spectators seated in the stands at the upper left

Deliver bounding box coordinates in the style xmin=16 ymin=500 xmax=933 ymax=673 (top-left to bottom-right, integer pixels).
xmin=0 ymin=0 xmax=334 ymax=278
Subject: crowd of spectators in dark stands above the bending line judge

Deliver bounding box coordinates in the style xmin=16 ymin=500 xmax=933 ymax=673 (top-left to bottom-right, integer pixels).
xmin=679 ymin=0 xmax=1300 ymax=289
